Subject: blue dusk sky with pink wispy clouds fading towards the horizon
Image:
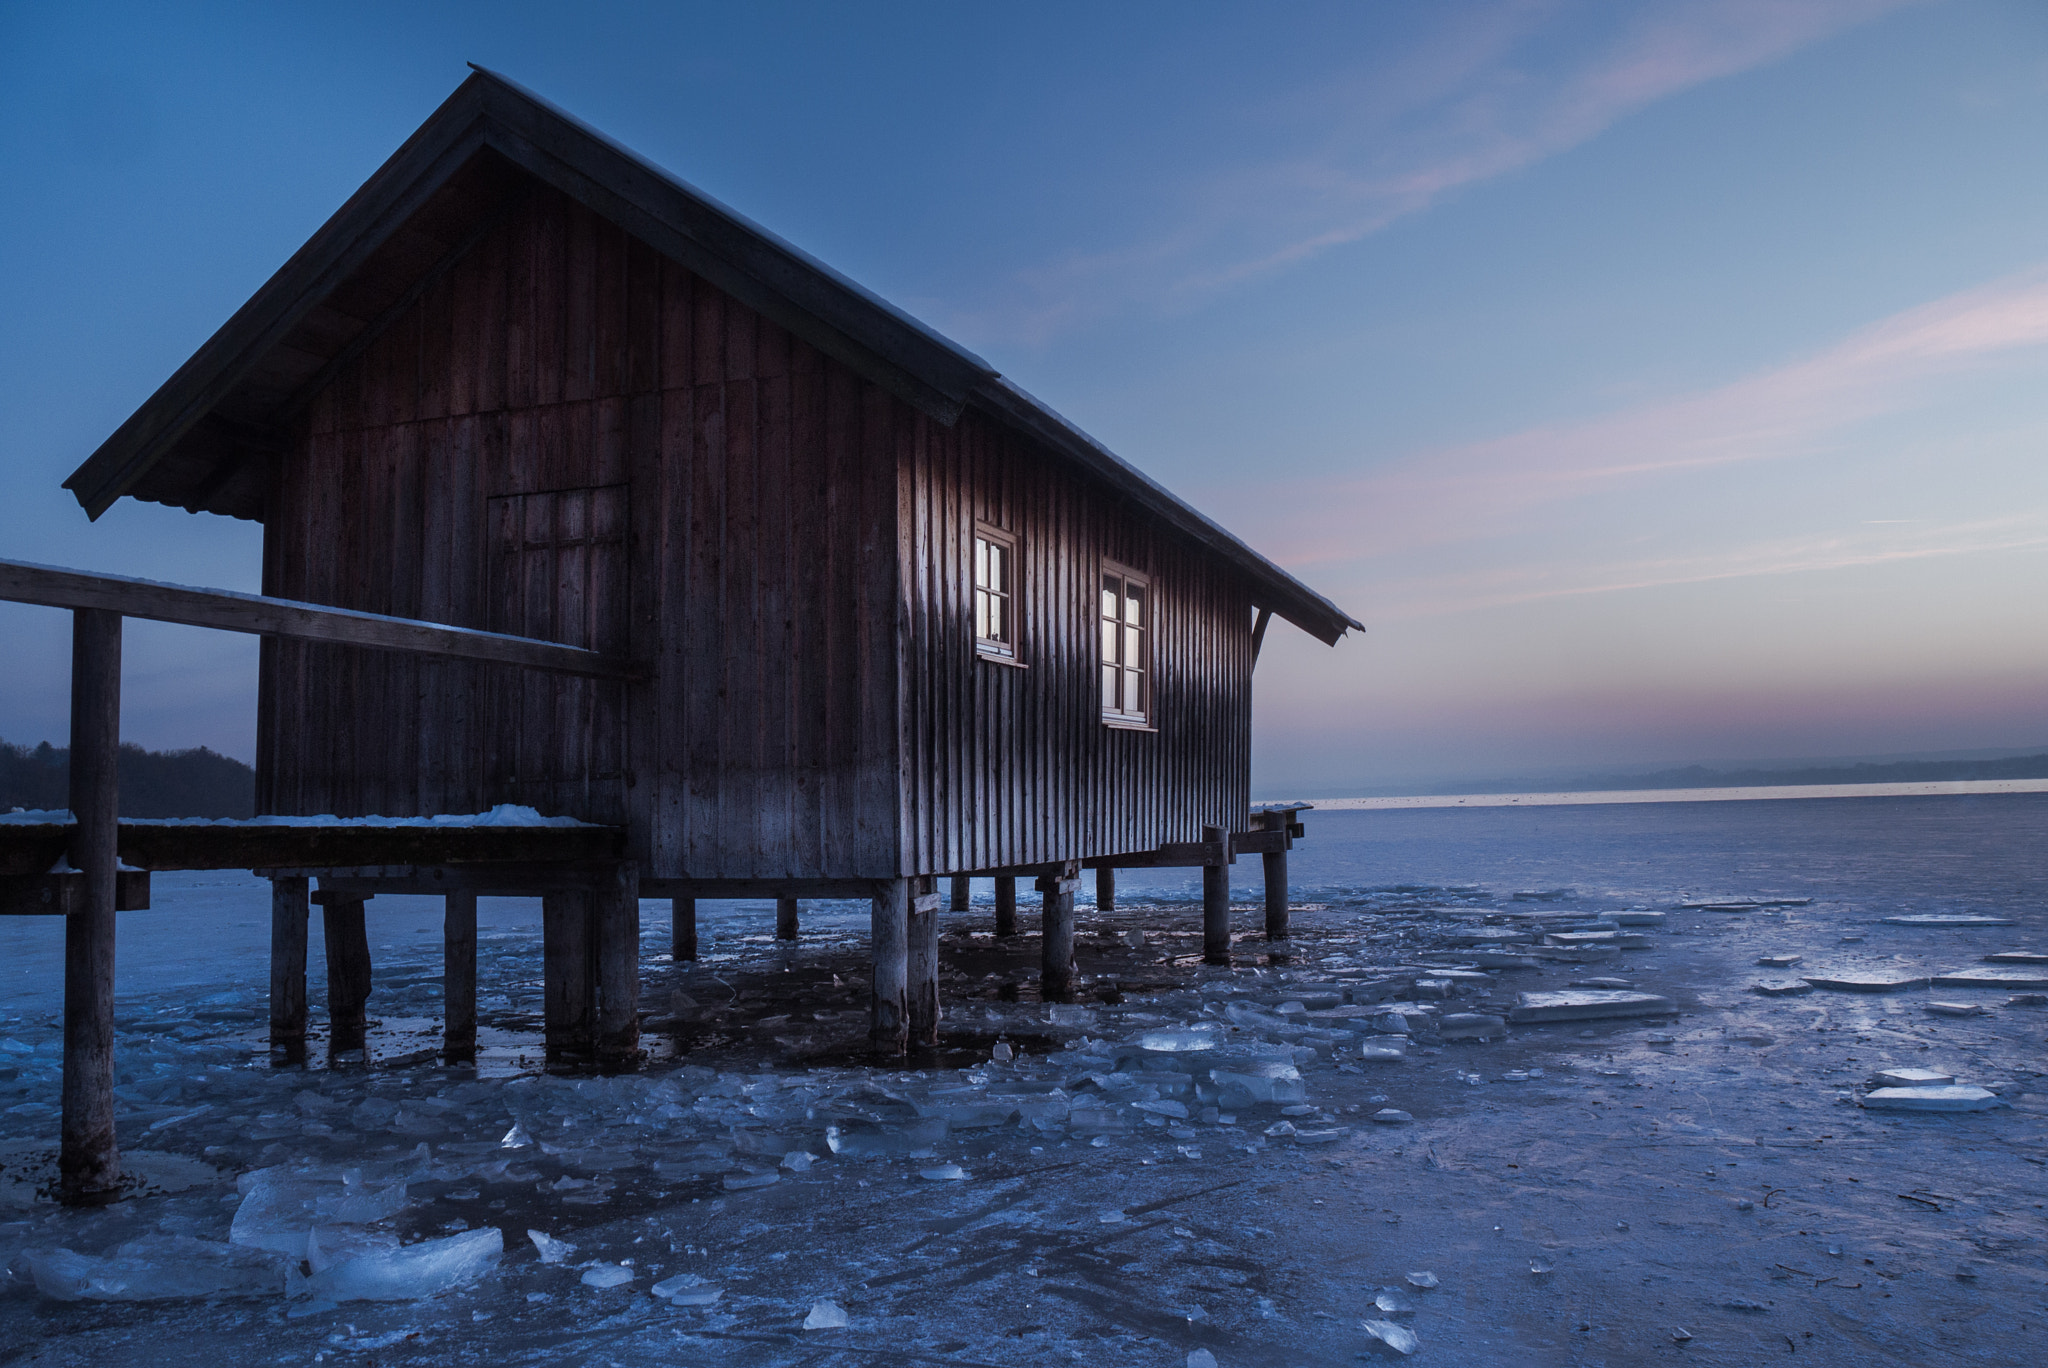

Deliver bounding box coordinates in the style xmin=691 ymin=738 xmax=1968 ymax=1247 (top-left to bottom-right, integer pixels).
xmin=0 ymin=0 xmax=2048 ymax=797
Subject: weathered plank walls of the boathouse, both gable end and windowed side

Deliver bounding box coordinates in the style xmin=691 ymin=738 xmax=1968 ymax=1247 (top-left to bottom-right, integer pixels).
xmin=258 ymin=165 xmax=1251 ymax=879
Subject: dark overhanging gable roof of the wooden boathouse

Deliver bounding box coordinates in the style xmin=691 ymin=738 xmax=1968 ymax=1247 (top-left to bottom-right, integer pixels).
xmin=63 ymin=66 xmax=1360 ymax=643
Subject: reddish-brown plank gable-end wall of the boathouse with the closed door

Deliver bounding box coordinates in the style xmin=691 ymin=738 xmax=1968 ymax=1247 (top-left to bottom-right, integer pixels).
xmin=258 ymin=179 xmax=913 ymax=877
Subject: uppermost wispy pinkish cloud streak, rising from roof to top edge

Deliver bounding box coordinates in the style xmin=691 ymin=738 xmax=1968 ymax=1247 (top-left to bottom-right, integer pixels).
xmin=950 ymin=0 xmax=1923 ymax=342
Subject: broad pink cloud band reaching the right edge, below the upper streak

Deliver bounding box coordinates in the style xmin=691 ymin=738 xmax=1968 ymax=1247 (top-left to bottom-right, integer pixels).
xmin=1266 ymin=264 xmax=2048 ymax=565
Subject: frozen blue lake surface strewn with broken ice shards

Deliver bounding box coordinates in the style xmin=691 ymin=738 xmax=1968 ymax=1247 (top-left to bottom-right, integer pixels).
xmin=0 ymin=795 xmax=2048 ymax=1368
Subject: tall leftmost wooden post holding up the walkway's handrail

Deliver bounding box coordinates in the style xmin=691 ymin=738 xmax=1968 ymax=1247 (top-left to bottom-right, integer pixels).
xmin=57 ymin=608 xmax=121 ymax=1206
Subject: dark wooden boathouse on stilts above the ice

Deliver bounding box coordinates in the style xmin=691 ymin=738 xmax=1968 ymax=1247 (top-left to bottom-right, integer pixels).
xmin=16 ymin=70 xmax=1358 ymax=1195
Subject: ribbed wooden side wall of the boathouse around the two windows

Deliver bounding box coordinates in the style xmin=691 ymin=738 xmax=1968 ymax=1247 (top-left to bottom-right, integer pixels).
xmin=899 ymin=410 xmax=1251 ymax=872
